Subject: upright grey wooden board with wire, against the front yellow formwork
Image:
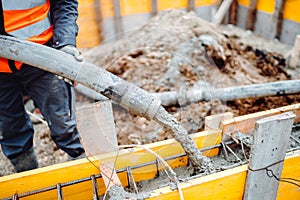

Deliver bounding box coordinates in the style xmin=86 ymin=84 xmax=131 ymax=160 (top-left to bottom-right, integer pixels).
xmin=243 ymin=112 xmax=295 ymax=200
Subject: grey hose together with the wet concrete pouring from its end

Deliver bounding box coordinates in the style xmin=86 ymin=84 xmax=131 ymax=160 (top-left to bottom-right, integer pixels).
xmin=0 ymin=35 xmax=211 ymax=171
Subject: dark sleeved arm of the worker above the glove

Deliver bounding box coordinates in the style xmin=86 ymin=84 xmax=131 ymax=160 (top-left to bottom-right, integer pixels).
xmin=51 ymin=0 xmax=78 ymax=49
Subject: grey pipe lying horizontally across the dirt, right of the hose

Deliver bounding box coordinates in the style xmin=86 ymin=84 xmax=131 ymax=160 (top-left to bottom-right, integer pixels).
xmin=152 ymin=80 xmax=300 ymax=106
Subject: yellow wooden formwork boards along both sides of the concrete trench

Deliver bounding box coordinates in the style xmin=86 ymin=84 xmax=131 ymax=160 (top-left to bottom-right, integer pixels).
xmin=0 ymin=104 xmax=300 ymax=199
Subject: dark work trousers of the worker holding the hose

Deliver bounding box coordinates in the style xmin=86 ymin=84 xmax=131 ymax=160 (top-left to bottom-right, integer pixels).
xmin=0 ymin=64 xmax=84 ymax=159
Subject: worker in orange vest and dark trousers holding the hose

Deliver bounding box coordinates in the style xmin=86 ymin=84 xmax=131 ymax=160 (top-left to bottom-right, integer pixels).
xmin=0 ymin=0 xmax=85 ymax=172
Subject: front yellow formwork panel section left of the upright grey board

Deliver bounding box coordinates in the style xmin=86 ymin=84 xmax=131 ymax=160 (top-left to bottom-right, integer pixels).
xmin=148 ymin=165 xmax=247 ymax=200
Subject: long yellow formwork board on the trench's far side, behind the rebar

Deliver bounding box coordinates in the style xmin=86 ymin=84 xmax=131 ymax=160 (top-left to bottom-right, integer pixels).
xmin=0 ymin=130 xmax=222 ymax=200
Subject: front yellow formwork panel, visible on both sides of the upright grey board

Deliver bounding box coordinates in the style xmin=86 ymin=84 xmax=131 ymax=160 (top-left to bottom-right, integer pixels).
xmin=147 ymin=151 xmax=300 ymax=200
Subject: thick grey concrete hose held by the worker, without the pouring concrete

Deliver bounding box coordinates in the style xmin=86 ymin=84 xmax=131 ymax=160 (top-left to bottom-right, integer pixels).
xmin=0 ymin=36 xmax=160 ymax=119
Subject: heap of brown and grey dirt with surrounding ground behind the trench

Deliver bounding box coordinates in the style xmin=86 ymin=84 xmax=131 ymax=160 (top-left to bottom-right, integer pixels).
xmin=0 ymin=10 xmax=300 ymax=176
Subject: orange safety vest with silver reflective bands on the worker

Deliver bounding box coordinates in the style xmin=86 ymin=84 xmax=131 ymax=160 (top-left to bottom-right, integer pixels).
xmin=0 ymin=0 xmax=53 ymax=73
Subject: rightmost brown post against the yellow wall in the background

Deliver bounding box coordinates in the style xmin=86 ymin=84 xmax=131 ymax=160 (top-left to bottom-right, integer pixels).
xmin=271 ymin=0 xmax=285 ymax=39
